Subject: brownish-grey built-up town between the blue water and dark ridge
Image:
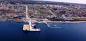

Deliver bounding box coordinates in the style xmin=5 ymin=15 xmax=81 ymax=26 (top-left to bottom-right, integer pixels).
xmin=0 ymin=1 xmax=86 ymax=21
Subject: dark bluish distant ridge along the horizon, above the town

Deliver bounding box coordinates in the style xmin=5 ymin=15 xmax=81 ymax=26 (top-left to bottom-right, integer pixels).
xmin=0 ymin=0 xmax=86 ymax=5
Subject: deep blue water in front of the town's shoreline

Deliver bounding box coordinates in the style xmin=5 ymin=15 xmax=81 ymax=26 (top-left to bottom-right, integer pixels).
xmin=0 ymin=22 xmax=86 ymax=41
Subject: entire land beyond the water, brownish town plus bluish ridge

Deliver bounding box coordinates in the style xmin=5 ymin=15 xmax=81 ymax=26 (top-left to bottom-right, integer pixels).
xmin=0 ymin=0 xmax=86 ymax=21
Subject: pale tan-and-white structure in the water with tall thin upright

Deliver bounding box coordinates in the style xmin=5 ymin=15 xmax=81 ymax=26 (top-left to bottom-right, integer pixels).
xmin=23 ymin=5 xmax=40 ymax=31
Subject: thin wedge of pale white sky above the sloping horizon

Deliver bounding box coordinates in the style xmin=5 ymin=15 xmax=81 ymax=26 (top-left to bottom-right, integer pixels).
xmin=33 ymin=0 xmax=86 ymax=4
